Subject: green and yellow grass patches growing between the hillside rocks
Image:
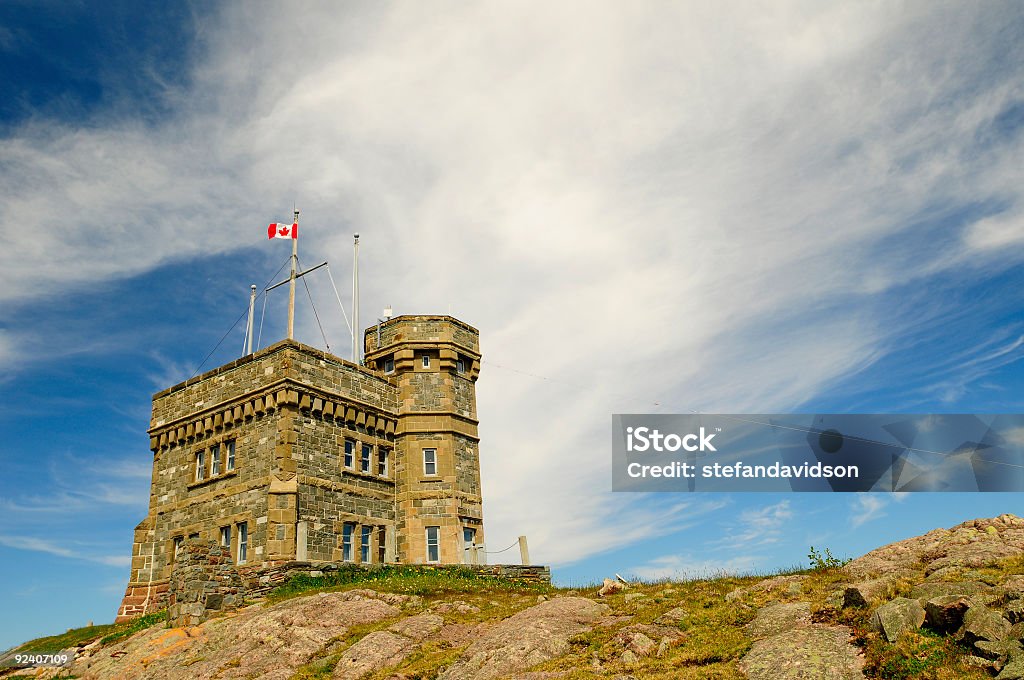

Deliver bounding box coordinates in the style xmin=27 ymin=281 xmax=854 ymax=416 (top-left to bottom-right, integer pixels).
xmin=9 ymin=551 xmax=1024 ymax=680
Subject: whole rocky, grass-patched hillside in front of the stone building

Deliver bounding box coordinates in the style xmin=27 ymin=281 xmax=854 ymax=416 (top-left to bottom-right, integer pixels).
xmin=5 ymin=515 xmax=1024 ymax=680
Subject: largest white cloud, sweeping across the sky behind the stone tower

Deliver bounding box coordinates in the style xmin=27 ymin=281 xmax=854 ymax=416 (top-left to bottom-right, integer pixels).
xmin=6 ymin=2 xmax=1024 ymax=561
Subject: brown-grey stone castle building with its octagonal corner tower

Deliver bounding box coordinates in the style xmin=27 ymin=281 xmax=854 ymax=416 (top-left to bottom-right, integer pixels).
xmin=118 ymin=315 xmax=483 ymax=620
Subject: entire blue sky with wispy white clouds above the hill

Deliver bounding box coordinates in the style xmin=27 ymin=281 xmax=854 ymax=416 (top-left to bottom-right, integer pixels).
xmin=0 ymin=0 xmax=1024 ymax=648
